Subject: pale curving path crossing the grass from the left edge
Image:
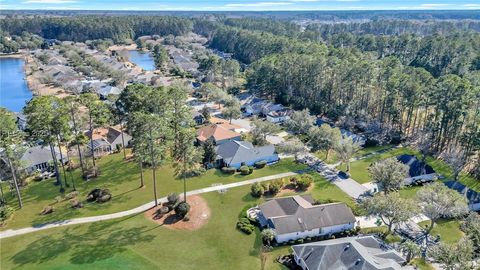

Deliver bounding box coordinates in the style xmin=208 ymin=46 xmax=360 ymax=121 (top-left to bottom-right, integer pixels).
xmin=0 ymin=171 xmax=302 ymax=239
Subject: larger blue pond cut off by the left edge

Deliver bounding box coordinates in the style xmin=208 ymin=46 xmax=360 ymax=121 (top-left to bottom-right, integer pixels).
xmin=0 ymin=58 xmax=32 ymax=112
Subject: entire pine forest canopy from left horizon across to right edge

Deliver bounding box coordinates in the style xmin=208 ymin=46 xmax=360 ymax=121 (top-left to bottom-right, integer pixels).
xmin=0 ymin=11 xmax=480 ymax=162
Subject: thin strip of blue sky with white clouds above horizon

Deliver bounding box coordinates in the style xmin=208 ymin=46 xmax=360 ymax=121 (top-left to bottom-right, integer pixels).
xmin=0 ymin=0 xmax=480 ymax=11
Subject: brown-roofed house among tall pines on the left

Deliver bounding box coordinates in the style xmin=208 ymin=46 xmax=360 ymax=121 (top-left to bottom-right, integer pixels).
xmin=85 ymin=127 xmax=132 ymax=156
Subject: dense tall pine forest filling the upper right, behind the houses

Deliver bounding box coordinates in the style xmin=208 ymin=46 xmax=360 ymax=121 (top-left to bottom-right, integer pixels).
xmin=194 ymin=18 xmax=480 ymax=169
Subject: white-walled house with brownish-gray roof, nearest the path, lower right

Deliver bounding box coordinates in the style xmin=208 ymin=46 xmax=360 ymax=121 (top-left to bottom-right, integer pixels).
xmin=257 ymin=195 xmax=356 ymax=243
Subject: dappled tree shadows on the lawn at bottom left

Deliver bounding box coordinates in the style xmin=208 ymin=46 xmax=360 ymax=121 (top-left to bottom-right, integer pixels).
xmin=12 ymin=217 xmax=154 ymax=266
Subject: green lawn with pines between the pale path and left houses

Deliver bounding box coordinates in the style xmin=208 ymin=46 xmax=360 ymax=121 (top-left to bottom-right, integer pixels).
xmin=1 ymin=154 xmax=306 ymax=230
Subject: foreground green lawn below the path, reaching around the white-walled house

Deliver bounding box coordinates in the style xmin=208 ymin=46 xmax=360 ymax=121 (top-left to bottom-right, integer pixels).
xmin=0 ymin=173 xmax=350 ymax=270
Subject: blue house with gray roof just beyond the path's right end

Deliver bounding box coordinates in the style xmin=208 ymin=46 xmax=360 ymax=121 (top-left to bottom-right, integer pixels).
xmin=216 ymin=140 xmax=280 ymax=169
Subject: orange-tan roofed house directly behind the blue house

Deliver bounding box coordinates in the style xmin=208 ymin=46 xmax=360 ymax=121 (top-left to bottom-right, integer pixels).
xmin=197 ymin=124 xmax=241 ymax=145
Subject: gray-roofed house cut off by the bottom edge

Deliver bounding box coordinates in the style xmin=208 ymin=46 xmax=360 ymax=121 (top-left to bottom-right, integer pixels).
xmin=292 ymin=236 xmax=406 ymax=270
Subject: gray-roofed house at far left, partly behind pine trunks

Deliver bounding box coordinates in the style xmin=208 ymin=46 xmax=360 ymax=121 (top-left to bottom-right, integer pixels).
xmin=20 ymin=145 xmax=68 ymax=173
